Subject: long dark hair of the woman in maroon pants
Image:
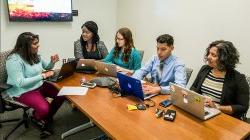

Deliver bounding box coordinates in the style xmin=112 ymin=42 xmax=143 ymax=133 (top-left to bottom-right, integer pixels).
xmin=8 ymin=32 xmax=40 ymax=65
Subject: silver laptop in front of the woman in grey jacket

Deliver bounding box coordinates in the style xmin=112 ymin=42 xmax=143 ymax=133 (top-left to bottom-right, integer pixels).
xmin=76 ymin=59 xmax=97 ymax=73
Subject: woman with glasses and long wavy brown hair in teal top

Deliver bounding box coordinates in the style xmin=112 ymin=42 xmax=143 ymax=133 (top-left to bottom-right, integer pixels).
xmin=103 ymin=28 xmax=141 ymax=73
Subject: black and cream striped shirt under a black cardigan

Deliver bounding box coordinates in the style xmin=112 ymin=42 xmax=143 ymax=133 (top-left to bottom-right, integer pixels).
xmin=201 ymin=71 xmax=225 ymax=103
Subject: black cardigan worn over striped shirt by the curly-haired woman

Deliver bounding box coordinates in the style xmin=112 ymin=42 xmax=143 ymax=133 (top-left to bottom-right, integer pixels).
xmin=190 ymin=65 xmax=249 ymax=118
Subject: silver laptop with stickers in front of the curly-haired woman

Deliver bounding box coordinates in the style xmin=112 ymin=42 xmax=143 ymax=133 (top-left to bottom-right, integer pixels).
xmin=170 ymin=83 xmax=220 ymax=120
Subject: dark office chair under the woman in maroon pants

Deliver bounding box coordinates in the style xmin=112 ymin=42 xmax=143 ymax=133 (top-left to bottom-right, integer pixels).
xmin=0 ymin=51 xmax=29 ymax=140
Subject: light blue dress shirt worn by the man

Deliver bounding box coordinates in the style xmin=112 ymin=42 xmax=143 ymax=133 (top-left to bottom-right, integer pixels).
xmin=132 ymin=55 xmax=187 ymax=94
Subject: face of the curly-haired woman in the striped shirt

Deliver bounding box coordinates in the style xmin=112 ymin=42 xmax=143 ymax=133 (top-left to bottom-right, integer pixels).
xmin=207 ymin=47 xmax=218 ymax=68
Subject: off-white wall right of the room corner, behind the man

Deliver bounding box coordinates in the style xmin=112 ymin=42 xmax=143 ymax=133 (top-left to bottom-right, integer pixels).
xmin=117 ymin=0 xmax=250 ymax=84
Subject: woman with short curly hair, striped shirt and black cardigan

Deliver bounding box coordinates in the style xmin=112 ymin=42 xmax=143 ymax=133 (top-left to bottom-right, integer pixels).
xmin=191 ymin=40 xmax=249 ymax=119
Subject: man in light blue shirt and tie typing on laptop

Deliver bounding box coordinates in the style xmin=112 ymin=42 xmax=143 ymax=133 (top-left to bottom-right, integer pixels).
xmin=132 ymin=34 xmax=187 ymax=94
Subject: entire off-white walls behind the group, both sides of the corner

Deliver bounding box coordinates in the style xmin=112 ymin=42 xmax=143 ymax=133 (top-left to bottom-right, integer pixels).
xmin=0 ymin=0 xmax=250 ymax=83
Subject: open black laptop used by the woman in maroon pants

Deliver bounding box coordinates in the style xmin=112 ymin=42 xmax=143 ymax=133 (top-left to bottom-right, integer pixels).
xmin=46 ymin=60 xmax=77 ymax=82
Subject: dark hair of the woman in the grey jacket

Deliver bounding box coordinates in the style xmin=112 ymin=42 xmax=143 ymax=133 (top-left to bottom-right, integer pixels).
xmin=80 ymin=21 xmax=100 ymax=51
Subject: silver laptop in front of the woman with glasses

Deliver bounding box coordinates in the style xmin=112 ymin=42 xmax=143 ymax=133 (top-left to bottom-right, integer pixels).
xmin=95 ymin=61 xmax=117 ymax=77
